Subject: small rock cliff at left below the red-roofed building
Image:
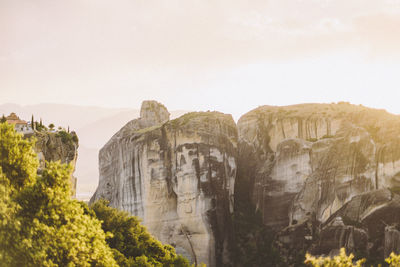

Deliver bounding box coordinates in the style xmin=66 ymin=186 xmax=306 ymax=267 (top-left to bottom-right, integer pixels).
xmin=26 ymin=131 xmax=78 ymax=197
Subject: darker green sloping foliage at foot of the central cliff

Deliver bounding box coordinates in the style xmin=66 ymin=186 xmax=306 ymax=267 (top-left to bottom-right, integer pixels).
xmin=91 ymin=200 xmax=189 ymax=267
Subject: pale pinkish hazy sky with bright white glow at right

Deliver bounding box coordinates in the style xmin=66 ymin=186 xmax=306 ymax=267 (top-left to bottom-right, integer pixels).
xmin=0 ymin=0 xmax=400 ymax=117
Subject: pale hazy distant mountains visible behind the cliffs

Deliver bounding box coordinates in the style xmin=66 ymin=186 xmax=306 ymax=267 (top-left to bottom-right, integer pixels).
xmin=0 ymin=103 xmax=188 ymax=199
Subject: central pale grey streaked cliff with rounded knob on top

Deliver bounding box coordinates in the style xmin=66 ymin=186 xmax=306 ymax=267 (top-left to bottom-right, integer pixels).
xmin=91 ymin=101 xmax=237 ymax=266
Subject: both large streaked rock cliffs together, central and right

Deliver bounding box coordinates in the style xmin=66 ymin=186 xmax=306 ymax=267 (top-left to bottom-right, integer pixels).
xmin=91 ymin=101 xmax=400 ymax=266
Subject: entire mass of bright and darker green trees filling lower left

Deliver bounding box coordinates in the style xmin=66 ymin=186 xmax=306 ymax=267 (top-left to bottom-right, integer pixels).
xmin=0 ymin=123 xmax=189 ymax=266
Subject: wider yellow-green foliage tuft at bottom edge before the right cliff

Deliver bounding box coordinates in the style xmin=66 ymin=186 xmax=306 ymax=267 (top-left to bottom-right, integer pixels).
xmin=304 ymin=248 xmax=365 ymax=267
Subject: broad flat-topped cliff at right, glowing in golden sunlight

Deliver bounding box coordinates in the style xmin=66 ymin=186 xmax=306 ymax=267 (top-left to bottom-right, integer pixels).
xmin=237 ymin=103 xmax=400 ymax=263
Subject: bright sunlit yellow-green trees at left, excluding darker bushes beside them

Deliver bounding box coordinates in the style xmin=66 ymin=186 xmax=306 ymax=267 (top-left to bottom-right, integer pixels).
xmin=0 ymin=124 xmax=117 ymax=266
